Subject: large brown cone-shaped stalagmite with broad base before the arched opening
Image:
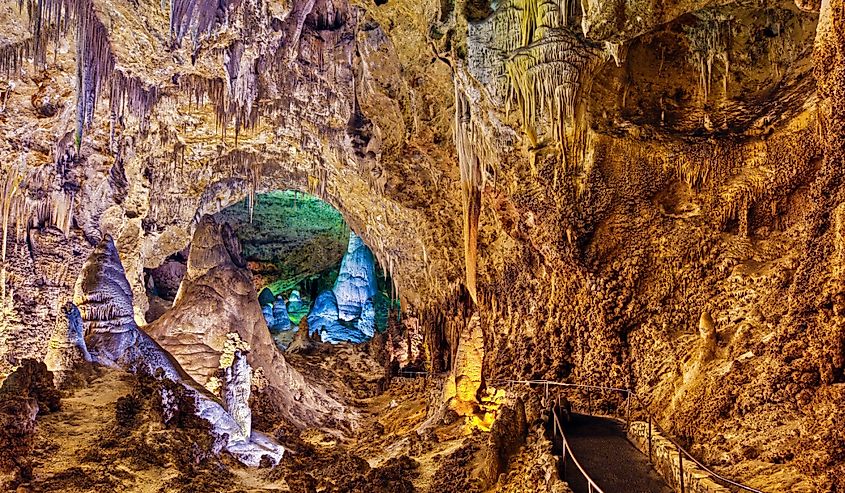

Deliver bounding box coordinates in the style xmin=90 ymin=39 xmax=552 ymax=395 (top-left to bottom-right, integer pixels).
xmin=145 ymin=216 xmax=355 ymax=426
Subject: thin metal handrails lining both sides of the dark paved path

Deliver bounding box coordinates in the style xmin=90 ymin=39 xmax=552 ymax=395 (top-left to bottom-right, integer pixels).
xmin=492 ymin=380 xmax=764 ymax=493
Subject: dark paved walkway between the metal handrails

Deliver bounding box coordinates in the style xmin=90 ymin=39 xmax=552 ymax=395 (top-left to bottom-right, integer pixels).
xmin=555 ymin=414 xmax=672 ymax=493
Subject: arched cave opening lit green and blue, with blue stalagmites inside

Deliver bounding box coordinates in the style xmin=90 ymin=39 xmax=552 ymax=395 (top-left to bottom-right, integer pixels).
xmin=215 ymin=190 xmax=394 ymax=349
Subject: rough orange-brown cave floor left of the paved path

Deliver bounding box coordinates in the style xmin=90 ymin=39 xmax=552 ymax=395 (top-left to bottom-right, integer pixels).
xmin=19 ymin=345 xmax=572 ymax=493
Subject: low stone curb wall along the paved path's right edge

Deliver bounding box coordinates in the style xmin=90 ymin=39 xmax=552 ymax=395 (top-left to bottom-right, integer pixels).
xmin=628 ymin=421 xmax=730 ymax=493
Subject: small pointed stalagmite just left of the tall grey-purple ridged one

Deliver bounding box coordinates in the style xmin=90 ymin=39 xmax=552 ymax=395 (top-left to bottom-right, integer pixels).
xmin=44 ymin=301 xmax=91 ymax=388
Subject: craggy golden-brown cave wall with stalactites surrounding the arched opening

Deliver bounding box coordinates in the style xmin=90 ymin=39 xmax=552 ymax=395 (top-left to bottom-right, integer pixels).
xmin=0 ymin=0 xmax=845 ymax=487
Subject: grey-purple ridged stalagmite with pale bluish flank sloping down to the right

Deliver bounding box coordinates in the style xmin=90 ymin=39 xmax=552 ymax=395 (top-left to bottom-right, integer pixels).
xmin=71 ymin=237 xmax=284 ymax=466
